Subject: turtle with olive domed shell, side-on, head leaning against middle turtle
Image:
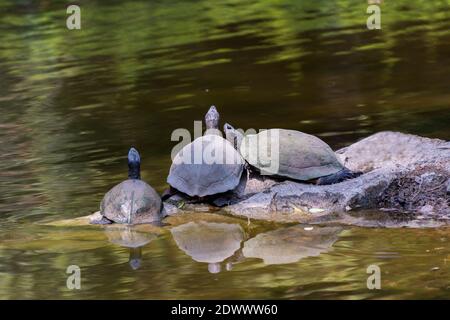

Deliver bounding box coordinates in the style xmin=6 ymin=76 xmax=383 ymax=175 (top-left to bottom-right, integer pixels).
xmin=224 ymin=123 xmax=362 ymax=185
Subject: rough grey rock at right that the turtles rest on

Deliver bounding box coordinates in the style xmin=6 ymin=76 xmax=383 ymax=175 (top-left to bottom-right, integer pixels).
xmin=166 ymin=132 xmax=450 ymax=222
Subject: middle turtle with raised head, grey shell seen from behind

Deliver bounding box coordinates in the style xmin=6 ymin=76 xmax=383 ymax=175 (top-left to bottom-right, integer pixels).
xmin=163 ymin=106 xmax=245 ymax=199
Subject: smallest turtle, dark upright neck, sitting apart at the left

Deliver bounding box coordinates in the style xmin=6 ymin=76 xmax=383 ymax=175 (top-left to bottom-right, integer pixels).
xmin=91 ymin=147 xmax=162 ymax=224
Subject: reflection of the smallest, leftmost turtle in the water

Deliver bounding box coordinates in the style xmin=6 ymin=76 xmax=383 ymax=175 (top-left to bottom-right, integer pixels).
xmin=105 ymin=225 xmax=157 ymax=270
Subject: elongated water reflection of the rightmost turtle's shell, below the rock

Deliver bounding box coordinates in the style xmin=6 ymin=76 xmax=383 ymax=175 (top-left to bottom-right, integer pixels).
xmin=242 ymin=226 xmax=342 ymax=264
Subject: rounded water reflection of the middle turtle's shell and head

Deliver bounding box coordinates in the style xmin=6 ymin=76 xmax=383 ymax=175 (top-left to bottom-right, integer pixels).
xmin=171 ymin=221 xmax=244 ymax=273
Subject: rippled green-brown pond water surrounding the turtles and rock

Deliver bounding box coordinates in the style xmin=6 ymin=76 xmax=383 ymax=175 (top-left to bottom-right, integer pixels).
xmin=0 ymin=0 xmax=450 ymax=299
